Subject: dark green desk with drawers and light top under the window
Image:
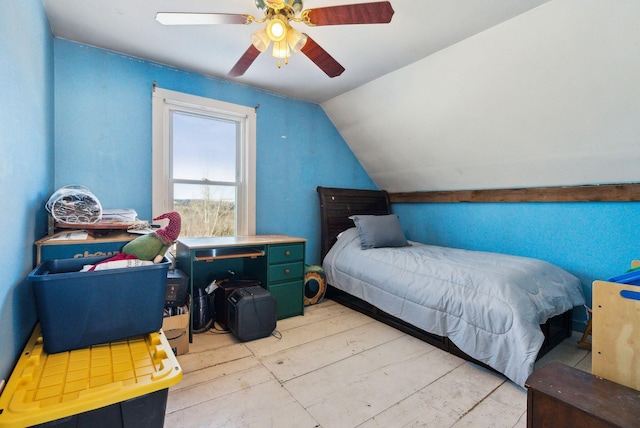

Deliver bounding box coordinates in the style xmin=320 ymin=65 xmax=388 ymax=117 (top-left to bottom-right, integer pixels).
xmin=176 ymin=235 xmax=306 ymax=342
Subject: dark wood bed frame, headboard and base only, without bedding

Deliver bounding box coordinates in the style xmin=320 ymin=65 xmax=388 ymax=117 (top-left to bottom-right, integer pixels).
xmin=317 ymin=187 xmax=572 ymax=370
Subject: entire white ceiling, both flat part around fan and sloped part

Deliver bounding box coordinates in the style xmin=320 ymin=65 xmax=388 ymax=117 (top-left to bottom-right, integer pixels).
xmin=44 ymin=0 xmax=640 ymax=192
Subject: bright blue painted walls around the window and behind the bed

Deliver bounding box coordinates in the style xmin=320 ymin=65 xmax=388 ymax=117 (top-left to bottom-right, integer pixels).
xmin=0 ymin=0 xmax=640 ymax=378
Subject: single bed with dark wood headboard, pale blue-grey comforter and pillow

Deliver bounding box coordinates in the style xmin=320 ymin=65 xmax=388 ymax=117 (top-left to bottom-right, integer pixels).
xmin=317 ymin=187 xmax=584 ymax=386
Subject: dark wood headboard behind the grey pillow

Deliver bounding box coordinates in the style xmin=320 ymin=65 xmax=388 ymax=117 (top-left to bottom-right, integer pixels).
xmin=316 ymin=186 xmax=391 ymax=260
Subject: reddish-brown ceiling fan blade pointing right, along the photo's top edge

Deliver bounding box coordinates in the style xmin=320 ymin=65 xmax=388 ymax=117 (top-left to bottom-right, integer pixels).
xmin=305 ymin=1 xmax=394 ymax=25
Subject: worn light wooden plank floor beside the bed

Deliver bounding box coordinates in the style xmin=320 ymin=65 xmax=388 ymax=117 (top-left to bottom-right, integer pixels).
xmin=165 ymin=300 xmax=591 ymax=428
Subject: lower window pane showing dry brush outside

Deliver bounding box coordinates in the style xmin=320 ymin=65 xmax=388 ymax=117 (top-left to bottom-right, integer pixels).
xmin=173 ymin=184 xmax=236 ymax=238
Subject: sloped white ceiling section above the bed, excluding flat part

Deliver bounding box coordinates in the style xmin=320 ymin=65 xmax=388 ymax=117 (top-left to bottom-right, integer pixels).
xmin=322 ymin=0 xmax=640 ymax=192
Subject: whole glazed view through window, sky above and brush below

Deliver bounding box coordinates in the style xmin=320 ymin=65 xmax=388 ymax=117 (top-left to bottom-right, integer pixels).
xmin=171 ymin=111 xmax=239 ymax=237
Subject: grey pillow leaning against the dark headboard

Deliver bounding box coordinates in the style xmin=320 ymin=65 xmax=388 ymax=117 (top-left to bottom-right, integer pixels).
xmin=349 ymin=214 xmax=409 ymax=250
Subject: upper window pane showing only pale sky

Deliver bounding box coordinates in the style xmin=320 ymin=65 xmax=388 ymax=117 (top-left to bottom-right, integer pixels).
xmin=172 ymin=111 xmax=237 ymax=183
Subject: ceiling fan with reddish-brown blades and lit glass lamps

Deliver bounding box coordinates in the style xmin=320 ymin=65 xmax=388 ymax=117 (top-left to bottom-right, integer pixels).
xmin=156 ymin=0 xmax=394 ymax=77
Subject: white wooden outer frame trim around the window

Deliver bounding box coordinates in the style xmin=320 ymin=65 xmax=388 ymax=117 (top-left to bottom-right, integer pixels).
xmin=151 ymin=87 xmax=256 ymax=236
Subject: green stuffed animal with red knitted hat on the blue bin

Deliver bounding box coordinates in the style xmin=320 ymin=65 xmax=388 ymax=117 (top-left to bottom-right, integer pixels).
xmin=122 ymin=211 xmax=181 ymax=263
